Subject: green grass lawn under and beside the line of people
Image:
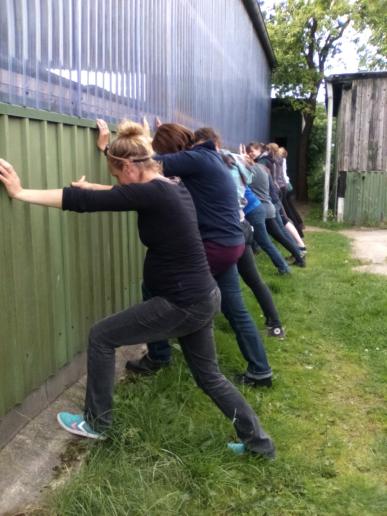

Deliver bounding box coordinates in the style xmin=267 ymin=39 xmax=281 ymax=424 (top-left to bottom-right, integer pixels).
xmin=42 ymin=232 xmax=387 ymax=516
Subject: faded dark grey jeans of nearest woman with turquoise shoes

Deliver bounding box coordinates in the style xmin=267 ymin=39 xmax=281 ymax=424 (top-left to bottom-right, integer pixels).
xmin=85 ymin=288 xmax=274 ymax=456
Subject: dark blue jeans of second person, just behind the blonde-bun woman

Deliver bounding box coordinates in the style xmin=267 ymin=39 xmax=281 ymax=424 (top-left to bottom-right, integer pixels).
xmin=148 ymin=265 xmax=272 ymax=379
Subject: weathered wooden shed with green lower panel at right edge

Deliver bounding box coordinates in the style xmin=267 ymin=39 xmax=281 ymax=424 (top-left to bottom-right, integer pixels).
xmin=326 ymin=71 xmax=387 ymax=226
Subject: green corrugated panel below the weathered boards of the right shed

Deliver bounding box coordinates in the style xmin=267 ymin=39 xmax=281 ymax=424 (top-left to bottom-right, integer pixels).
xmin=344 ymin=171 xmax=387 ymax=226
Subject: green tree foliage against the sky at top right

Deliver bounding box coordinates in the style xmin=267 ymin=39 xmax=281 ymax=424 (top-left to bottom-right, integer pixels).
xmin=263 ymin=0 xmax=387 ymax=101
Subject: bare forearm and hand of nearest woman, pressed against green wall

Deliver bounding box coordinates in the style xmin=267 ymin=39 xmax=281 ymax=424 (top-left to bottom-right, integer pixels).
xmin=0 ymin=159 xmax=63 ymax=208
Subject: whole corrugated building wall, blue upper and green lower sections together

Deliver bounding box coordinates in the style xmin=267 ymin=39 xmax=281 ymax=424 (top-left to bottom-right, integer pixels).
xmin=0 ymin=0 xmax=270 ymax=418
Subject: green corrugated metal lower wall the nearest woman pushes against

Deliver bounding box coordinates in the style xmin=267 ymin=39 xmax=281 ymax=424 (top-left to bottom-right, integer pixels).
xmin=0 ymin=104 xmax=143 ymax=417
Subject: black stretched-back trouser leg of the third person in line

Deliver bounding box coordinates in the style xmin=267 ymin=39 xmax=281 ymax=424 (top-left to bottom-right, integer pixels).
xmin=237 ymin=244 xmax=281 ymax=327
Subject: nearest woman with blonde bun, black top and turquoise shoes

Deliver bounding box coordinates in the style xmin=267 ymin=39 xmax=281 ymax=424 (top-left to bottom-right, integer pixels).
xmin=0 ymin=122 xmax=275 ymax=458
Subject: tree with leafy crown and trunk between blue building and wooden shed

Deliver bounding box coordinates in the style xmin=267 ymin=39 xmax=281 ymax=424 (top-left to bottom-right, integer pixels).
xmin=264 ymin=0 xmax=353 ymax=200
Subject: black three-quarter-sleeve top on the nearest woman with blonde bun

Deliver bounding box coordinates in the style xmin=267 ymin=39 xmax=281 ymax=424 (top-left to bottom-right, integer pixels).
xmin=62 ymin=179 xmax=216 ymax=306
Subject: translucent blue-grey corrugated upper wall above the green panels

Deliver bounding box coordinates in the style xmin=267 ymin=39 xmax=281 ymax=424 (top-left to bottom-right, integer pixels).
xmin=0 ymin=0 xmax=270 ymax=147
